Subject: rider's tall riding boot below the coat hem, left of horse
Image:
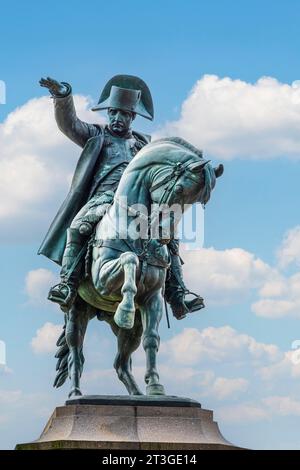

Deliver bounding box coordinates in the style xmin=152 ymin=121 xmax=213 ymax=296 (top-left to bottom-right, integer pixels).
xmin=48 ymin=228 xmax=86 ymax=312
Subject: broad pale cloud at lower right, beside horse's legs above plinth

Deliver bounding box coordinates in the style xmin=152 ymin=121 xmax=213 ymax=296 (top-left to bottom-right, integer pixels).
xmin=160 ymin=325 xmax=300 ymax=400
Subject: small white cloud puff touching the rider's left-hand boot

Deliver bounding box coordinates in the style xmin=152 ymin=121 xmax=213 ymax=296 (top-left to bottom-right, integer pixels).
xmin=25 ymin=268 xmax=58 ymax=305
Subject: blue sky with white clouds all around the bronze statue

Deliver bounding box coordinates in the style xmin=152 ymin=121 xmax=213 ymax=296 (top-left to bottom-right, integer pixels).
xmin=0 ymin=0 xmax=300 ymax=449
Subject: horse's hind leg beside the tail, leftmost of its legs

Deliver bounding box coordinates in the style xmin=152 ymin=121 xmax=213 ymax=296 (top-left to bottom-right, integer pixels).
xmin=66 ymin=297 xmax=89 ymax=397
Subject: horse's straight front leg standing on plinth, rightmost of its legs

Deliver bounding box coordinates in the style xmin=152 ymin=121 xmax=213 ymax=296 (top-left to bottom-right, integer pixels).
xmin=140 ymin=291 xmax=165 ymax=395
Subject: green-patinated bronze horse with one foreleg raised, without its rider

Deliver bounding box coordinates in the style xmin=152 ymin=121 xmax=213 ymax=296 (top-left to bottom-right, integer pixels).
xmin=54 ymin=137 xmax=223 ymax=398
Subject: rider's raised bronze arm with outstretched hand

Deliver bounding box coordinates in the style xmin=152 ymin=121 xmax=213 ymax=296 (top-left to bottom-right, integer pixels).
xmin=39 ymin=77 xmax=101 ymax=147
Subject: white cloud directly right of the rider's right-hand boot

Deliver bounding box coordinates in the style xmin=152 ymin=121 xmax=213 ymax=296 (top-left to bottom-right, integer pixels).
xmin=182 ymin=248 xmax=274 ymax=304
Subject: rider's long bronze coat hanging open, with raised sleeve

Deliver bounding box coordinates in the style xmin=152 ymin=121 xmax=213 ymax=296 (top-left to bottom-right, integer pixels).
xmin=38 ymin=94 xmax=149 ymax=264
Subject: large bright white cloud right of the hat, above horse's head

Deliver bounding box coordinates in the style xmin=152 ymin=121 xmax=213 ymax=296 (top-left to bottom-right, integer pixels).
xmin=159 ymin=75 xmax=300 ymax=159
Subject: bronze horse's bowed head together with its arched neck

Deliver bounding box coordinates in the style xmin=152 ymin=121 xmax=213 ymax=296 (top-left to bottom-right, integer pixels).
xmin=115 ymin=137 xmax=223 ymax=241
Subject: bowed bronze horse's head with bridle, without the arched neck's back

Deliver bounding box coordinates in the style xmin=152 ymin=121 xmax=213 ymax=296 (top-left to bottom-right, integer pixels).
xmin=150 ymin=138 xmax=224 ymax=242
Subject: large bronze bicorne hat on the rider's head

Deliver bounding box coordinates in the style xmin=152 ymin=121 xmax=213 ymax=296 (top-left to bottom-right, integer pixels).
xmin=92 ymin=75 xmax=154 ymax=121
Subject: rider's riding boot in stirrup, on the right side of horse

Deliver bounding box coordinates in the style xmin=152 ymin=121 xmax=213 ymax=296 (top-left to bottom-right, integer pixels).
xmin=165 ymin=240 xmax=204 ymax=320
